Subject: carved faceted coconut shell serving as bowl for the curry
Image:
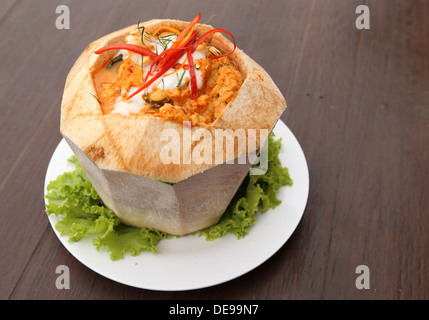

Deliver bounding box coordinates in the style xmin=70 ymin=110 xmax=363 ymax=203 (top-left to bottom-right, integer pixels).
xmin=61 ymin=20 xmax=286 ymax=235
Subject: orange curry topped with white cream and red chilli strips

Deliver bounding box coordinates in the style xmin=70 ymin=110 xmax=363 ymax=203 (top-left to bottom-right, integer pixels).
xmin=93 ymin=14 xmax=243 ymax=125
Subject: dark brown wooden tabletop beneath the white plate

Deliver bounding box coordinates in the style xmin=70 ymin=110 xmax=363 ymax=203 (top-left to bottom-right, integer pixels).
xmin=0 ymin=0 xmax=429 ymax=299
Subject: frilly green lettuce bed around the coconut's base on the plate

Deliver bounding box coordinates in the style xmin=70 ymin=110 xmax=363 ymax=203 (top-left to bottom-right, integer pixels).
xmin=45 ymin=135 xmax=292 ymax=260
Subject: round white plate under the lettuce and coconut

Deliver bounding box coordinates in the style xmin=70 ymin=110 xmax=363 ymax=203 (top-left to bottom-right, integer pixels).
xmin=45 ymin=121 xmax=309 ymax=291
